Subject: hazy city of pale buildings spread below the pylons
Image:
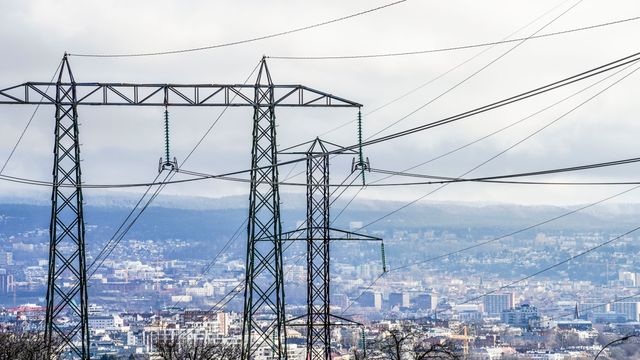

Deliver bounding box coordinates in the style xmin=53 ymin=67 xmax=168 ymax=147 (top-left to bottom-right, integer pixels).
xmin=0 ymin=196 xmax=640 ymax=359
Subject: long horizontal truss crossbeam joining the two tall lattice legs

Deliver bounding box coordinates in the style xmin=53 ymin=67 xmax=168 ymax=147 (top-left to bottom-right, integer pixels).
xmin=0 ymin=82 xmax=362 ymax=108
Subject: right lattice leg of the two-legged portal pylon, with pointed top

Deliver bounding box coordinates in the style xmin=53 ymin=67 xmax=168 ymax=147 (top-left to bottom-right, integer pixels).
xmin=242 ymin=59 xmax=287 ymax=360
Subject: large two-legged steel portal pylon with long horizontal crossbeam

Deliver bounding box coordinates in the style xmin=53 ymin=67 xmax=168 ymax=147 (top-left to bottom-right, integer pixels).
xmin=0 ymin=54 xmax=361 ymax=360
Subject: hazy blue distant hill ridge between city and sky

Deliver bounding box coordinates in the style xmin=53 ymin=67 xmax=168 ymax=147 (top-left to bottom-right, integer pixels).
xmin=0 ymin=192 xmax=640 ymax=230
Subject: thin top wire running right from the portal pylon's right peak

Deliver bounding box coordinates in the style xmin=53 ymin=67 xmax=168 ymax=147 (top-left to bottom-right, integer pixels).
xmin=268 ymin=16 xmax=640 ymax=60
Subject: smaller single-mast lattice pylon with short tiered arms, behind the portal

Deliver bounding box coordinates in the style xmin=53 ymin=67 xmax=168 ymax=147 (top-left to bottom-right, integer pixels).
xmin=283 ymin=138 xmax=382 ymax=360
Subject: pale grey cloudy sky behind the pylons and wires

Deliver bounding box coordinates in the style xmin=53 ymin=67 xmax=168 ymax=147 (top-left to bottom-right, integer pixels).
xmin=0 ymin=0 xmax=640 ymax=204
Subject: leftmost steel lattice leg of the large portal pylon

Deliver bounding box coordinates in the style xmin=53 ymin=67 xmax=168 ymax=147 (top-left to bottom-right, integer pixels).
xmin=45 ymin=55 xmax=89 ymax=359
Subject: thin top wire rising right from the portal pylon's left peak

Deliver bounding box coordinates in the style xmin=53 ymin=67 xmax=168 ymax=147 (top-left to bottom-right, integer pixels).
xmin=69 ymin=0 xmax=408 ymax=58
